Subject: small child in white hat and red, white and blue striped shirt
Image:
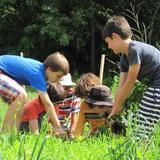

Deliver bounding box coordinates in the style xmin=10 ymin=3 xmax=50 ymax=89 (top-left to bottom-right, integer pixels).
xmin=55 ymin=73 xmax=80 ymax=136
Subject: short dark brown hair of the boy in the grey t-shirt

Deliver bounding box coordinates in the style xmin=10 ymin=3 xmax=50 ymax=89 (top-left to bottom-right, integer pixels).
xmin=102 ymin=16 xmax=132 ymax=39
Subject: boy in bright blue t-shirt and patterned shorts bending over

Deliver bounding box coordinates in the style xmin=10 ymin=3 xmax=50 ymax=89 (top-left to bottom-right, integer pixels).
xmin=0 ymin=52 xmax=69 ymax=135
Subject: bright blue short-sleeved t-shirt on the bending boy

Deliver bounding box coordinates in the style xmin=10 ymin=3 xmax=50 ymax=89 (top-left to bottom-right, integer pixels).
xmin=0 ymin=55 xmax=47 ymax=92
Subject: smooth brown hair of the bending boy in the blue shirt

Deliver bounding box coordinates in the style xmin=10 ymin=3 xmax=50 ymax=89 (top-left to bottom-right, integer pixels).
xmin=44 ymin=52 xmax=69 ymax=75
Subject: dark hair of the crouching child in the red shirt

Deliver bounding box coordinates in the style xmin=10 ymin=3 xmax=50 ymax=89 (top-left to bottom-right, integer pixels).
xmin=47 ymin=82 xmax=66 ymax=102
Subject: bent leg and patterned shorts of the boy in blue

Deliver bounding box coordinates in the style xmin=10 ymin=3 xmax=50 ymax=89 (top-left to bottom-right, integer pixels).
xmin=0 ymin=74 xmax=27 ymax=132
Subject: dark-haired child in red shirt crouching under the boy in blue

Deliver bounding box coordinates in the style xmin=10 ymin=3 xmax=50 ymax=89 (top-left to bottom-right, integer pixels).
xmin=20 ymin=82 xmax=66 ymax=134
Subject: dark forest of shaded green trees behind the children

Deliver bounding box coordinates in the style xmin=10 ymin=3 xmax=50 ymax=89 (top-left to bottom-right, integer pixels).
xmin=0 ymin=0 xmax=160 ymax=77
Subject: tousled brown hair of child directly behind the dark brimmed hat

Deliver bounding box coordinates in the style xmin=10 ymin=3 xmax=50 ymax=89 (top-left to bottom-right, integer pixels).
xmin=75 ymin=73 xmax=100 ymax=97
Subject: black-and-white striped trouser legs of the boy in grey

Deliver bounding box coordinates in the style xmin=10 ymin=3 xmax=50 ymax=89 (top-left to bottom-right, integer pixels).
xmin=135 ymin=87 xmax=160 ymax=138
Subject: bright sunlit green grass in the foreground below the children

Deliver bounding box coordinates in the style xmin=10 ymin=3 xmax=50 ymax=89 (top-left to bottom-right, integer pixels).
xmin=0 ymin=87 xmax=160 ymax=160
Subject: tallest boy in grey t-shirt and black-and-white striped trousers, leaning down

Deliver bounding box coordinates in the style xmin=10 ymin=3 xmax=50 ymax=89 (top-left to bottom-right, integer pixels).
xmin=102 ymin=16 xmax=160 ymax=137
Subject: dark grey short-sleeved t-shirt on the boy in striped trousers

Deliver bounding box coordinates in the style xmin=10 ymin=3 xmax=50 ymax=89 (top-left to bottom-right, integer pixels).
xmin=120 ymin=41 xmax=160 ymax=87
